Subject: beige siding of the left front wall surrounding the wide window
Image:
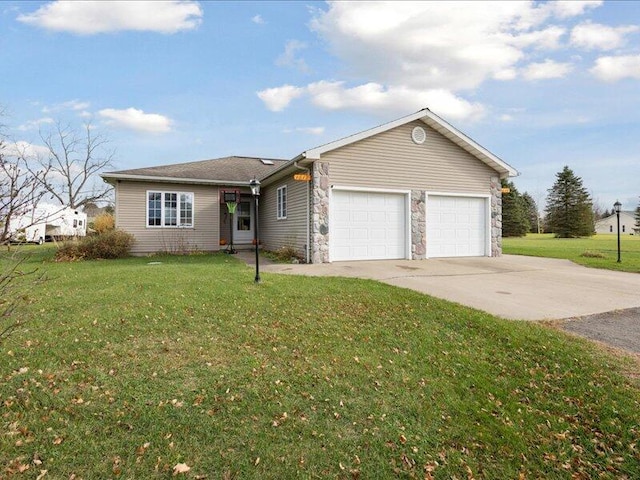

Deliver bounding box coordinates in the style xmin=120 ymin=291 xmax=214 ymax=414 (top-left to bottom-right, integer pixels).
xmin=116 ymin=181 xmax=220 ymax=255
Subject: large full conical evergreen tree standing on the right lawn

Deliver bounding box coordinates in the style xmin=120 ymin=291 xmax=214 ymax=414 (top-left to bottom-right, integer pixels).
xmin=545 ymin=166 xmax=594 ymax=238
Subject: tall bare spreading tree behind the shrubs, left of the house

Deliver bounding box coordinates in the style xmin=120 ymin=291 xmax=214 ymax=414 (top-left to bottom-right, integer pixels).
xmin=32 ymin=123 xmax=114 ymax=208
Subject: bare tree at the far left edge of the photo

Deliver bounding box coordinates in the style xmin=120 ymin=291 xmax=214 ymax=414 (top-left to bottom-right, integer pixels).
xmin=0 ymin=140 xmax=45 ymax=244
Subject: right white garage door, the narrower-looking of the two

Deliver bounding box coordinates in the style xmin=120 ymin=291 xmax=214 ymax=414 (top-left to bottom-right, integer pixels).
xmin=427 ymin=195 xmax=487 ymax=258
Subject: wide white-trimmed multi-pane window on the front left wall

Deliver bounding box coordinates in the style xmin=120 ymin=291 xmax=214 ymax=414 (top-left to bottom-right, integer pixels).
xmin=147 ymin=191 xmax=193 ymax=227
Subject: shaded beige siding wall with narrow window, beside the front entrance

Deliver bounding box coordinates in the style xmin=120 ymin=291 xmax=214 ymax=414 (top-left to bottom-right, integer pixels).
xmin=260 ymin=170 xmax=309 ymax=258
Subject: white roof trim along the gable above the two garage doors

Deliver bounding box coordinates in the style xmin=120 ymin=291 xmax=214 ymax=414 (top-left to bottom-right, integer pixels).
xmin=294 ymin=108 xmax=519 ymax=178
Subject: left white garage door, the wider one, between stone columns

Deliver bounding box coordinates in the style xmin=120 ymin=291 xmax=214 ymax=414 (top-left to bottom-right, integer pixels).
xmin=330 ymin=190 xmax=406 ymax=261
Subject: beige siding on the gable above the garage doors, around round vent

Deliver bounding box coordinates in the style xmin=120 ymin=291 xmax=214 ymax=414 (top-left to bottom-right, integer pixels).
xmin=321 ymin=121 xmax=496 ymax=195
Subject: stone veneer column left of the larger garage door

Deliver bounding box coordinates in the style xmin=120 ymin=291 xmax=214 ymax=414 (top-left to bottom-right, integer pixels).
xmin=311 ymin=162 xmax=329 ymax=263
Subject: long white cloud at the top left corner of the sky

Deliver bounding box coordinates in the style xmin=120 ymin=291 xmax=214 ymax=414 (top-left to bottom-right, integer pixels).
xmin=18 ymin=0 xmax=203 ymax=35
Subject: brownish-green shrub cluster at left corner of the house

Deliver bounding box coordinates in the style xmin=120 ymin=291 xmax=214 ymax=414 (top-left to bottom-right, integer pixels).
xmin=56 ymin=230 xmax=135 ymax=262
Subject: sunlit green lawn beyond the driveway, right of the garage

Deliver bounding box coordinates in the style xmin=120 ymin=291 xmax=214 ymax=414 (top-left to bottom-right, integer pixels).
xmin=502 ymin=234 xmax=640 ymax=273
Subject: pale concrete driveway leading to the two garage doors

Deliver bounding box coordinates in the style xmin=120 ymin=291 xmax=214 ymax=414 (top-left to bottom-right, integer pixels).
xmin=262 ymin=255 xmax=640 ymax=320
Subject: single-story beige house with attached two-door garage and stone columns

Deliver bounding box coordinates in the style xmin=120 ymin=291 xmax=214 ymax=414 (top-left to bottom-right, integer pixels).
xmin=102 ymin=109 xmax=517 ymax=263
